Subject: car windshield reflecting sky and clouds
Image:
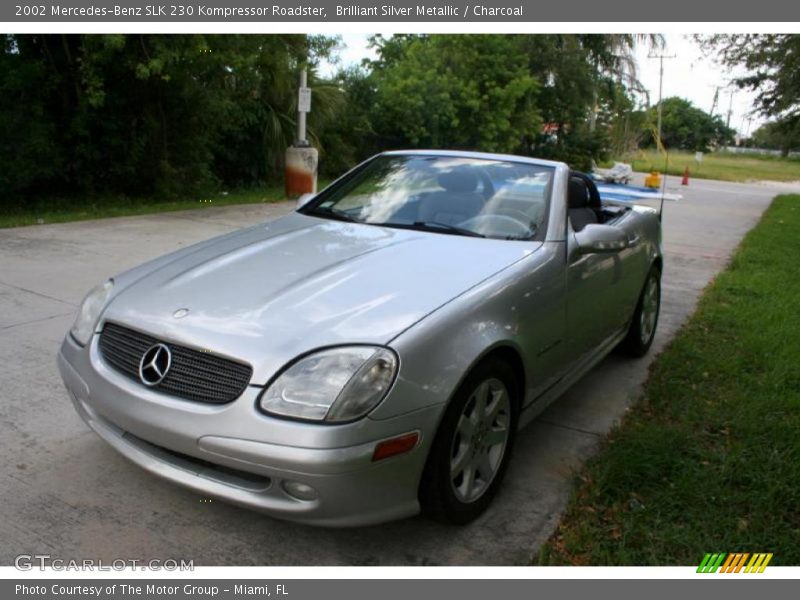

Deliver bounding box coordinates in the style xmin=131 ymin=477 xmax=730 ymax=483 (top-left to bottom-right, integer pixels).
xmin=302 ymin=155 xmax=553 ymax=240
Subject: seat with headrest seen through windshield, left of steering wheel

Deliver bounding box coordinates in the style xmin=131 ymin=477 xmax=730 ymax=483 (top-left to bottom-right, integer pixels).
xmin=417 ymin=167 xmax=486 ymax=225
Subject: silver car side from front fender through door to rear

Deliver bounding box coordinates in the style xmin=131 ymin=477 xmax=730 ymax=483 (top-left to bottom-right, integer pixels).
xmin=370 ymin=200 xmax=661 ymax=426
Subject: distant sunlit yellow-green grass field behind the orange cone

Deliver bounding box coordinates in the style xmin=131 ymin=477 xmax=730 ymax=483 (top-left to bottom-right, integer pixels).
xmin=617 ymin=151 xmax=800 ymax=183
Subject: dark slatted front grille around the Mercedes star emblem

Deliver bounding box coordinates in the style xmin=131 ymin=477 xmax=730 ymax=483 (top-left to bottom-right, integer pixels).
xmin=100 ymin=323 xmax=253 ymax=404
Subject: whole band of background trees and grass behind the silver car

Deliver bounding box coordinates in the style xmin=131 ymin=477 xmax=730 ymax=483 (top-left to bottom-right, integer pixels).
xmin=0 ymin=34 xmax=800 ymax=225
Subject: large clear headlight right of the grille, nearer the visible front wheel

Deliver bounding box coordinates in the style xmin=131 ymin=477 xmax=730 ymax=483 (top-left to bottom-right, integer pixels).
xmin=260 ymin=346 xmax=397 ymax=422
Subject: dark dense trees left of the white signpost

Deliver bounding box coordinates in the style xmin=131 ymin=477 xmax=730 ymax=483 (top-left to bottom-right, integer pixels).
xmin=0 ymin=35 xmax=343 ymax=203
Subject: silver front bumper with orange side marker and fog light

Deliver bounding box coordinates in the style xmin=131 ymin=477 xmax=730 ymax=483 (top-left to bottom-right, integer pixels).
xmin=58 ymin=335 xmax=442 ymax=526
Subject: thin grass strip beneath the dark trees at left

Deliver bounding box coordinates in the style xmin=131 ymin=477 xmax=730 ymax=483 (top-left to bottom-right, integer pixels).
xmin=0 ymin=185 xmax=296 ymax=228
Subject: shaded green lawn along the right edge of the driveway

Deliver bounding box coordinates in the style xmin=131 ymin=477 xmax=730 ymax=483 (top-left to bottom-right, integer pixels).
xmin=539 ymin=195 xmax=800 ymax=565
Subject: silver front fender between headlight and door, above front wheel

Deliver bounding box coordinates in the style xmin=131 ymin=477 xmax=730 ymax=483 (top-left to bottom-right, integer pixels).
xmin=370 ymin=242 xmax=565 ymax=419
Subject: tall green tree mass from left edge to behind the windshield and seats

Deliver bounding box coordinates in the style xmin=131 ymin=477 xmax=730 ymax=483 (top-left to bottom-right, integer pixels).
xmin=0 ymin=34 xmax=656 ymax=210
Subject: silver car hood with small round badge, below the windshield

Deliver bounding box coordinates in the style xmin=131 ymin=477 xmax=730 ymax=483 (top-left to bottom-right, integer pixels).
xmin=103 ymin=213 xmax=541 ymax=383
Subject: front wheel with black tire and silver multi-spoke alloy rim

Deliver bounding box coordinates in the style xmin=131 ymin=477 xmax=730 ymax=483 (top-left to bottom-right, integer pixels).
xmin=420 ymin=358 xmax=519 ymax=525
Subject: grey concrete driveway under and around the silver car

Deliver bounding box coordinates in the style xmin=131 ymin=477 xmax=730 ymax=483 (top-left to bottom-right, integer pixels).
xmin=0 ymin=178 xmax=788 ymax=565
